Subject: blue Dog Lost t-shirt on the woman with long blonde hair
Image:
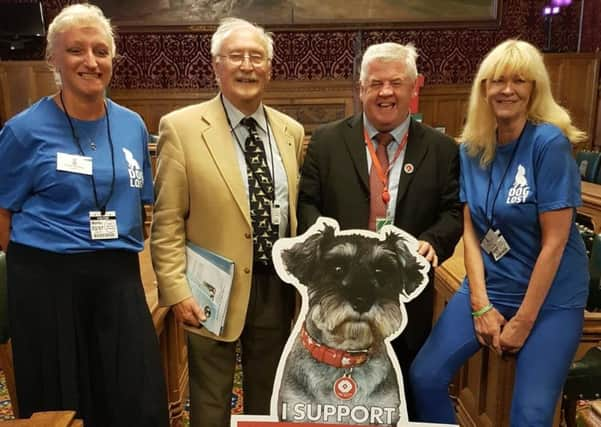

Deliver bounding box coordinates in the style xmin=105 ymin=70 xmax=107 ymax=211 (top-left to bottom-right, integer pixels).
xmin=460 ymin=122 xmax=589 ymax=309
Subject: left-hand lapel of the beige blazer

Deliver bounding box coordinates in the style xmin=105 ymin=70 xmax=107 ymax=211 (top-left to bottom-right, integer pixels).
xmin=201 ymin=96 xmax=251 ymax=225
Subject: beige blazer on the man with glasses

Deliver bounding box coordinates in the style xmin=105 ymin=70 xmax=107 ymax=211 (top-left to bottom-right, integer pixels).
xmin=150 ymin=96 xmax=304 ymax=341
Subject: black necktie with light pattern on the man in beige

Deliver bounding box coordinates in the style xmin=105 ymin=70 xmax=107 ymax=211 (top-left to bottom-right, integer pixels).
xmin=240 ymin=117 xmax=278 ymax=264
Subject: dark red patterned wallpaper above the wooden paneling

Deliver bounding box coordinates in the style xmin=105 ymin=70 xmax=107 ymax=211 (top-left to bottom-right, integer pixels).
xmin=34 ymin=0 xmax=601 ymax=89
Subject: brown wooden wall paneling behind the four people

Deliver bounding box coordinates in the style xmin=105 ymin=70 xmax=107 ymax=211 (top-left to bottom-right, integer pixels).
xmin=0 ymin=53 xmax=601 ymax=148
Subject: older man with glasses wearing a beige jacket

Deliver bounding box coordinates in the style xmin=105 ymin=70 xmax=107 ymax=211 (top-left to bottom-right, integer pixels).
xmin=151 ymin=18 xmax=304 ymax=427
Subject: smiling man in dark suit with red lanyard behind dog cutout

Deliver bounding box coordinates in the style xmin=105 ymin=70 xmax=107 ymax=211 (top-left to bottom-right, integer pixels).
xmin=298 ymin=43 xmax=462 ymax=417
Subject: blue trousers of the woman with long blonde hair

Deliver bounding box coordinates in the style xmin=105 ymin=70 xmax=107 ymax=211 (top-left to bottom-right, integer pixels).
xmin=409 ymin=293 xmax=584 ymax=427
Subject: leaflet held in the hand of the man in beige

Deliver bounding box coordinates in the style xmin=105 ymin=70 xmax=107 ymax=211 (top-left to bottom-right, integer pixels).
xmin=186 ymin=242 xmax=234 ymax=335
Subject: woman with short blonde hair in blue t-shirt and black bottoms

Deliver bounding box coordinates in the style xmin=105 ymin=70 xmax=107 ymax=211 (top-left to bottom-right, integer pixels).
xmin=0 ymin=4 xmax=168 ymax=427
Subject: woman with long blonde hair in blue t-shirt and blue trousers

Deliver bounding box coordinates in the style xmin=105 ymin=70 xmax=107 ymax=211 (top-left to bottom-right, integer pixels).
xmin=410 ymin=40 xmax=589 ymax=427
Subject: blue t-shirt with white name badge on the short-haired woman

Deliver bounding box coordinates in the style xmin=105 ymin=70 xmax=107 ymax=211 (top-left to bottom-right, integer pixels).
xmin=0 ymin=97 xmax=153 ymax=253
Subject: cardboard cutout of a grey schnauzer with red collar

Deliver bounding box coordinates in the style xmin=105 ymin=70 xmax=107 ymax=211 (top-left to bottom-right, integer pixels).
xmin=232 ymin=218 xmax=458 ymax=427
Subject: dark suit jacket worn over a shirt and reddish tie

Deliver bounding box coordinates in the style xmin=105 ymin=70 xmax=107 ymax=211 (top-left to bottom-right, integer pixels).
xmin=298 ymin=114 xmax=463 ymax=347
